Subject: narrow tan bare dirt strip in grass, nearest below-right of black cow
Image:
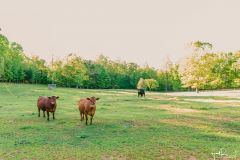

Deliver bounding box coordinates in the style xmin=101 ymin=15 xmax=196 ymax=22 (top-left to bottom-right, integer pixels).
xmin=147 ymin=104 xmax=200 ymax=113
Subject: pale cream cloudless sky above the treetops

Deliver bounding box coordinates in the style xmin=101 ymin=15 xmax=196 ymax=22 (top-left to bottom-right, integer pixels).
xmin=0 ymin=0 xmax=240 ymax=68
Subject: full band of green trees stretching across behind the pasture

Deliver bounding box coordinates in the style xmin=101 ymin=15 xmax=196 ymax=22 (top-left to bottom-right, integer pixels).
xmin=0 ymin=34 xmax=240 ymax=91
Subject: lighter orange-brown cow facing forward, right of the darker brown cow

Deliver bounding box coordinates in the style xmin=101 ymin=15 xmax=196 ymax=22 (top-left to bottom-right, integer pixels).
xmin=78 ymin=97 xmax=100 ymax=125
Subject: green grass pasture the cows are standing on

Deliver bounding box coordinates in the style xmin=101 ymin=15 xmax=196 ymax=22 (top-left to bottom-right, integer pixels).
xmin=0 ymin=83 xmax=240 ymax=160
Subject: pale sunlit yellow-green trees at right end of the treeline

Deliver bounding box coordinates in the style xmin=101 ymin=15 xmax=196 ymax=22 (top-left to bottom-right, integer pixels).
xmin=179 ymin=41 xmax=240 ymax=92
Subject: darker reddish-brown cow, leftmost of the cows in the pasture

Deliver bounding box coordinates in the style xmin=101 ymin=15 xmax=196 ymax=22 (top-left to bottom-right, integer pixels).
xmin=37 ymin=96 xmax=59 ymax=121
